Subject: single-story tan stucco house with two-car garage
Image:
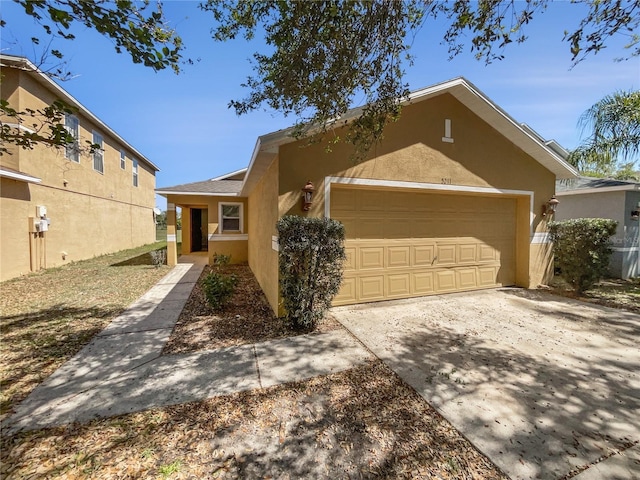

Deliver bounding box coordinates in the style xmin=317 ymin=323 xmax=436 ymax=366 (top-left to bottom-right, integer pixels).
xmin=157 ymin=78 xmax=576 ymax=312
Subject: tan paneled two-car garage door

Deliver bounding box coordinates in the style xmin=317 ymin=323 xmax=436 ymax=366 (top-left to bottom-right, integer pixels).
xmin=331 ymin=185 xmax=516 ymax=305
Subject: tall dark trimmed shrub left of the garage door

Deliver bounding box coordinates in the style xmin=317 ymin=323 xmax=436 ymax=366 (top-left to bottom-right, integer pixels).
xmin=277 ymin=215 xmax=346 ymax=329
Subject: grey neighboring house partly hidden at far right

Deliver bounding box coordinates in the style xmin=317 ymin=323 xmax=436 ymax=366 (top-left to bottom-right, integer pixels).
xmin=556 ymin=177 xmax=640 ymax=279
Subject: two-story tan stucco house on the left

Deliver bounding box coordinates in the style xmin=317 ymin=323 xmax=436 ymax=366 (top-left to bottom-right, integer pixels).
xmin=0 ymin=55 xmax=158 ymax=280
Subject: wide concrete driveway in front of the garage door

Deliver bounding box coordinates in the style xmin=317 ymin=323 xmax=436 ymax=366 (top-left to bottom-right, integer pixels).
xmin=332 ymin=289 xmax=640 ymax=480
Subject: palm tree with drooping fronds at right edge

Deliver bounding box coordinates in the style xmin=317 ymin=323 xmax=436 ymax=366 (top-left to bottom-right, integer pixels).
xmin=569 ymin=90 xmax=640 ymax=175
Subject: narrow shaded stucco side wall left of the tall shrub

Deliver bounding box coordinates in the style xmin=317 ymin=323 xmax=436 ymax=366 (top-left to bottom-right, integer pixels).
xmin=249 ymin=158 xmax=279 ymax=313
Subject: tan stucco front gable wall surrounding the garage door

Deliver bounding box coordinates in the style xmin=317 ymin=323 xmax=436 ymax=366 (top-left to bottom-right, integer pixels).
xmin=278 ymin=94 xmax=555 ymax=287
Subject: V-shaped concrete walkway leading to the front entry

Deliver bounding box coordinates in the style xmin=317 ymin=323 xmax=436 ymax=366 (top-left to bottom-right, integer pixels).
xmin=3 ymin=258 xmax=370 ymax=434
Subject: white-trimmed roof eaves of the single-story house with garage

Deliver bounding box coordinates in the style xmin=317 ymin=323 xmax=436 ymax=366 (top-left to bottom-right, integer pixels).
xmin=241 ymin=77 xmax=577 ymax=196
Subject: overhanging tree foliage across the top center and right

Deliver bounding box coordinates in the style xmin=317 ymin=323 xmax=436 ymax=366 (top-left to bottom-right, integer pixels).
xmin=201 ymin=0 xmax=640 ymax=157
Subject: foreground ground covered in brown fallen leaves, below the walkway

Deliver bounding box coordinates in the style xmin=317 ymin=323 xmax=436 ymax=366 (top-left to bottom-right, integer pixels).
xmin=0 ymin=360 xmax=507 ymax=480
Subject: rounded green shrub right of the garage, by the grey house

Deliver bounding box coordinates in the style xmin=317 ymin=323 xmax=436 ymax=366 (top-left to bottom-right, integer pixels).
xmin=549 ymin=218 xmax=618 ymax=295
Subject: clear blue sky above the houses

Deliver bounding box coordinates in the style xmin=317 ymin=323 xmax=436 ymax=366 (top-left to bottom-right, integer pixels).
xmin=0 ymin=0 xmax=640 ymax=209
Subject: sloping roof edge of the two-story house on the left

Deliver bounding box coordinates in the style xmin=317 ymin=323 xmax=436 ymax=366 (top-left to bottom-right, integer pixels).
xmin=0 ymin=54 xmax=160 ymax=172
